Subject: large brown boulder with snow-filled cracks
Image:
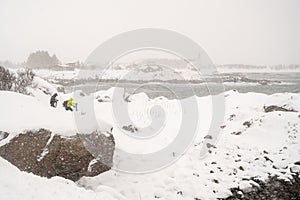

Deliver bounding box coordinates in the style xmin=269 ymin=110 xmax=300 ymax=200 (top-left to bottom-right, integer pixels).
xmin=0 ymin=129 xmax=115 ymax=181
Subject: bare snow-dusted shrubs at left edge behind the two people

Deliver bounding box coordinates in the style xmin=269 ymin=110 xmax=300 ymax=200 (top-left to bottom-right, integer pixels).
xmin=0 ymin=66 xmax=35 ymax=94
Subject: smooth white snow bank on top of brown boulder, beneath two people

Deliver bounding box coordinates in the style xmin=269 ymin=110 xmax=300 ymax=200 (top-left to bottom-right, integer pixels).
xmin=0 ymin=77 xmax=111 ymax=136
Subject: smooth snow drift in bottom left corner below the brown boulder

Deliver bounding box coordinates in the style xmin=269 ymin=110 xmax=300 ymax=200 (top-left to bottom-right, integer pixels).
xmin=0 ymin=157 xmax=126 ymax=200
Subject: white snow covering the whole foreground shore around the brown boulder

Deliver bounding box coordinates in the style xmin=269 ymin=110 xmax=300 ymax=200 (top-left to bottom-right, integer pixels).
xmin=0 ymin=76 xmax=300 ymax=200
